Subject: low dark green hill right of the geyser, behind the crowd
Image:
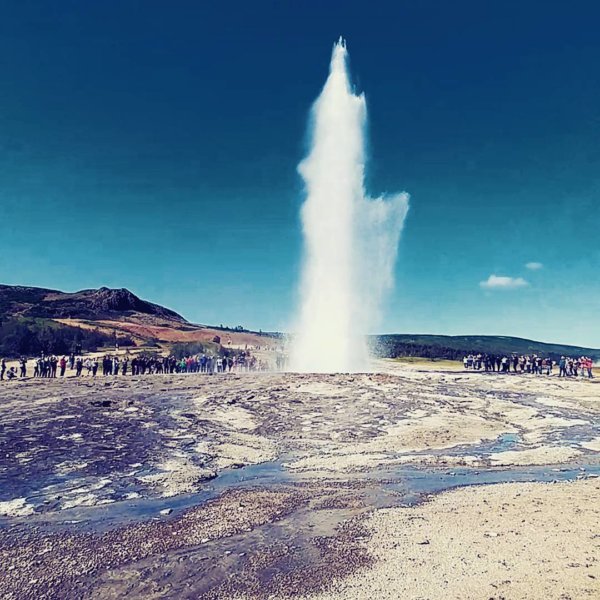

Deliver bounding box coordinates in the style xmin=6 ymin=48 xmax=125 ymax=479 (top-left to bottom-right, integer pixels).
xmin=371 ymin=334 xmax=600 ymax=360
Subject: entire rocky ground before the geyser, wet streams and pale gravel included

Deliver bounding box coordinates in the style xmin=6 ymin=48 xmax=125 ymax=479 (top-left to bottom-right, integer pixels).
xmin=0 ymin=362 xmax=600 ymax=599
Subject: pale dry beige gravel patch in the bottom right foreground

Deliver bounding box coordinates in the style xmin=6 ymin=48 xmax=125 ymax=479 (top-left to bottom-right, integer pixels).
xmin=296 ymin=479 xmax=600 ymax=600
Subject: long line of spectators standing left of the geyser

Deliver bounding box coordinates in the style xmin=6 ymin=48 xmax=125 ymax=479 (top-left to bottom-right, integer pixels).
xmin=0 ymin=351 xmax=269 ymax=381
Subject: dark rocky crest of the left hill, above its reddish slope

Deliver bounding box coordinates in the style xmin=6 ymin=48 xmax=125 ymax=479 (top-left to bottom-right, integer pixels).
xmin=0 ymin=285 xmax=186 ymax=323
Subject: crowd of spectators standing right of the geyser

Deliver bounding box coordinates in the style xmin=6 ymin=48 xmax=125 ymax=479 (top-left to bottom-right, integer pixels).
xmin=463 ymin=354 xmax=594 ymax=379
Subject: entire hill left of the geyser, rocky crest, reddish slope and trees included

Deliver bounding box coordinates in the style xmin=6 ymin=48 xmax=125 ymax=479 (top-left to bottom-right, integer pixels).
xmin=0 ymin=284 xmax=280 ymax=356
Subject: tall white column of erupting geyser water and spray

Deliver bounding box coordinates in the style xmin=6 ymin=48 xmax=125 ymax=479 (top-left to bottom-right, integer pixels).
xmin=290 ymin=38 xmax=408 ymax=373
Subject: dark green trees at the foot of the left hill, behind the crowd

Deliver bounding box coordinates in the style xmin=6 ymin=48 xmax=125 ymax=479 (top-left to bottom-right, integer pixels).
xmin=0 ymin=319 xmax=135 ymax=357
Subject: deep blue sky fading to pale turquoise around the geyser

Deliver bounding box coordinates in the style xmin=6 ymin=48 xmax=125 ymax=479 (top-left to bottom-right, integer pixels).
xmin=0 ymin=0 xmax=600 ymax=347
